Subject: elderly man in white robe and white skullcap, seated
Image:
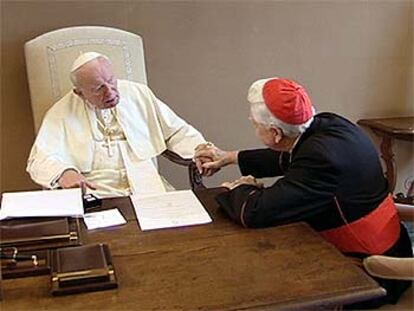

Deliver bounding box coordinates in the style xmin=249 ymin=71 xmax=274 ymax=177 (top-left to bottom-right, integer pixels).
xmin=27 ymin=52 xmax=205 ymax=197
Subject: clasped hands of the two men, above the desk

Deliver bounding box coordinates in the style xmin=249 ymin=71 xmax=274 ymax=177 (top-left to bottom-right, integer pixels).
xmin=194 ymin=143 xmax=239 ymax=176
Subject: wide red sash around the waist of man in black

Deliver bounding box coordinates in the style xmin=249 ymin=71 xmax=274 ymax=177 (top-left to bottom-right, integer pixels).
xmin=319 ymin=195 xmax=400 ymax=255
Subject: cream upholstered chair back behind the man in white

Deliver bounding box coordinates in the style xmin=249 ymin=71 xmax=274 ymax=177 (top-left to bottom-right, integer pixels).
xmin=25 ymin=26 xmax=147 ymax=133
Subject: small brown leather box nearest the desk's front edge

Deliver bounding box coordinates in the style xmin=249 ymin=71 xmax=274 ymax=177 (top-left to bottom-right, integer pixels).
xmin=50 ymin=244 xmax=118 ymax=295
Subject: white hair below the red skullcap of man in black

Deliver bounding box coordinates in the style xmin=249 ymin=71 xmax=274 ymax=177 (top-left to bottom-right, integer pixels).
xmin=249 ymin=102 xmax=315 ymax=137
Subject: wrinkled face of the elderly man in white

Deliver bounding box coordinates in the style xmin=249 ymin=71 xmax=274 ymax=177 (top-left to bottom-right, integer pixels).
xmin=74 ymin=57 xmax=119 ymax=109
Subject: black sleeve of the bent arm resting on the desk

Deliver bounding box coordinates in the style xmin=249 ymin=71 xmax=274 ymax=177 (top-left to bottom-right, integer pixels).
xmin=217 ymin=146 xmax=338 ymax=227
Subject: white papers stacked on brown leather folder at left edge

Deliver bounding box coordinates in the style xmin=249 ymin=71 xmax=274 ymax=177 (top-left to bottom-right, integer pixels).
xmin=0 ymin=188 xmax=83 ymax=220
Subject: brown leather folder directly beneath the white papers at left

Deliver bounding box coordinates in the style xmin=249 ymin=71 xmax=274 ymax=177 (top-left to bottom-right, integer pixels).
xmin=0 ymin=218 xmax=82 ymax=251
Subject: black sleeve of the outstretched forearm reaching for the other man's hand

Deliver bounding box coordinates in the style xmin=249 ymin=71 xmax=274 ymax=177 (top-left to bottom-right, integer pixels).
xmin=238 ymin=149 xmax=289 ymax=178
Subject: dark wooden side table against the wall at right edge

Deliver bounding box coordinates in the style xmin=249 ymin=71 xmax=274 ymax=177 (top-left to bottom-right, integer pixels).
xmin=357 ymin=117 xmax=414 ymax=192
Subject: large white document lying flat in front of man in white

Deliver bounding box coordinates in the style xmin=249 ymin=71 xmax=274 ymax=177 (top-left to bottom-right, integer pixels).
xmin=131 ymin=190 xmax=212 ymax=231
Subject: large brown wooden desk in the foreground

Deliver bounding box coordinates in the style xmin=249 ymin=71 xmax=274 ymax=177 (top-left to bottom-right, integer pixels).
xmin=0 ymin=189 xmax=384 ymax=311
